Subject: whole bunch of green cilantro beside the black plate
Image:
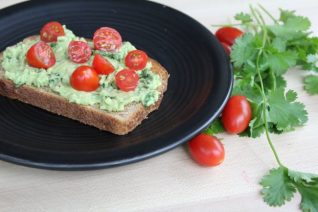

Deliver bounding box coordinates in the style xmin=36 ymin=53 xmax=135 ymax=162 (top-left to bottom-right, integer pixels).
xmin=209 ymin=6 xmax=318 ymax=211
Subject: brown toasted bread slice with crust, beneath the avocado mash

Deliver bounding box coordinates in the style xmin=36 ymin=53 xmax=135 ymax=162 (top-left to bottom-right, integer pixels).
xmin=0 ymin=36 xmax=169 ymax=135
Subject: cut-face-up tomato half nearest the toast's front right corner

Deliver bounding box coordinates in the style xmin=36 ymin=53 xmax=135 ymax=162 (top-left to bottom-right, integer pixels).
xmin=115 ymin=69 xmax=139 ymax=91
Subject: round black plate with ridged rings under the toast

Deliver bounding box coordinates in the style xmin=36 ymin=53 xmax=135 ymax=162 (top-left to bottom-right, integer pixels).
xmin=0 ymin=0 xmax=232 ymax=170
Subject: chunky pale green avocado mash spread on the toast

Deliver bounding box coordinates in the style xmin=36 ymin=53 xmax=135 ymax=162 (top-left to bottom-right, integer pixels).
xmin=2 ymin=26 xmax=162 ymax=111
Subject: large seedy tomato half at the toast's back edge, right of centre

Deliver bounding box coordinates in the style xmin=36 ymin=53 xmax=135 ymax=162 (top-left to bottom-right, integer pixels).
xmin=93 ymin=27 xmax=122 ymax=52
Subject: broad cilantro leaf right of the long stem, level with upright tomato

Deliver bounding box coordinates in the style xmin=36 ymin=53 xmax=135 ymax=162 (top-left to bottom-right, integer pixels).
xmin=268 ymin=88 xmax=308 ymax=131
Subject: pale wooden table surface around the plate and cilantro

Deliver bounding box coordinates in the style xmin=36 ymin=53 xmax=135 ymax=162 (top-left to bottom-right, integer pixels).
xmin=0 ymin=0 xmax=318 ymax=212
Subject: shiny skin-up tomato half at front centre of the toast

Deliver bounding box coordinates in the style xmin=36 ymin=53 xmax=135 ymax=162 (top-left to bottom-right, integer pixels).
xmin=70 ymin=66 xmax=99 ymax=92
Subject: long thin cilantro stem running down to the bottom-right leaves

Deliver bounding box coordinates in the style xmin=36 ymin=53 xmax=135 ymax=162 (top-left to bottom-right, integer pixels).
xmin=250 ymin=6 xmax=285 ymax=167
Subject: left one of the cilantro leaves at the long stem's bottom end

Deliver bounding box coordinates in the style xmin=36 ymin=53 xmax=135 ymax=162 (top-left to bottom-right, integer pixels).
xmin=260 ymin=167 xmax=296 ymax=206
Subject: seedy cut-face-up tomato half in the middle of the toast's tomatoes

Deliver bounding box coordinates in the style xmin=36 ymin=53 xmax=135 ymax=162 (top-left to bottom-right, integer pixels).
xmin=68 ymin=41 xmax=92 ymax=63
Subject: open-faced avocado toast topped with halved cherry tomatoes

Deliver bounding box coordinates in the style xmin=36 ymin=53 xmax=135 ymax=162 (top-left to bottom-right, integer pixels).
xmin=0 ymin=22 xmax=169 ymax=135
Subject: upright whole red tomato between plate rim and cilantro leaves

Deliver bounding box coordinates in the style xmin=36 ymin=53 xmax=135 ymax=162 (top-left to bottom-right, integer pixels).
xmin=222 ymin=96 xmax=252 ymax=134
